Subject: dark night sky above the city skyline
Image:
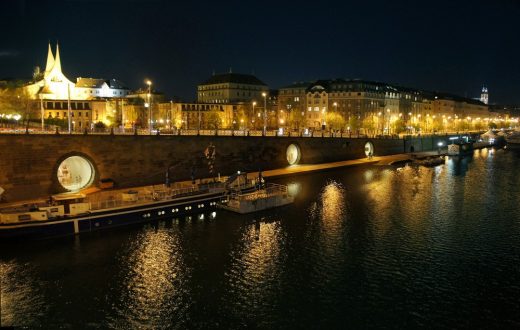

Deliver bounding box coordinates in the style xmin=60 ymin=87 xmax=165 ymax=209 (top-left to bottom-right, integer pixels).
xmin=0 ymin=0 xmax=520 ymax=103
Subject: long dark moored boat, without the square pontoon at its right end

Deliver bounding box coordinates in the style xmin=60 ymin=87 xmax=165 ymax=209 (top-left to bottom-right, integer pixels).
xmin=0 ymin=182 xmax=227 ymax=240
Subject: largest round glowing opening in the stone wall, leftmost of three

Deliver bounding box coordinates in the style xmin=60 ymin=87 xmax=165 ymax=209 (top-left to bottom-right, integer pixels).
xmin=57 ymin=156 xmax=94 ymax=191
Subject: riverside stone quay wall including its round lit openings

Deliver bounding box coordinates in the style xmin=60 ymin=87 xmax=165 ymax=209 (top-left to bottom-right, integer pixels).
xmin=0 ymin=130 xmax=480 ymax=201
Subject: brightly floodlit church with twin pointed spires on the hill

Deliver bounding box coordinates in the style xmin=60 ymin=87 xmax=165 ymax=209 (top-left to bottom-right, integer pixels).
xmin=24 ymin=43 xmax=130 ymax=100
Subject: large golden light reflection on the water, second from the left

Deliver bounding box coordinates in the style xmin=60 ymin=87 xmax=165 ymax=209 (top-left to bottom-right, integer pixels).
xmin=104 ymin=230 xmax=188 ymax=328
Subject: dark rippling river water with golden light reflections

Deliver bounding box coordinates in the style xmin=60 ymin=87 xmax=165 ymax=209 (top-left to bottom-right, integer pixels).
xmin=0 ymin=149 xmax=520 ymax=329
